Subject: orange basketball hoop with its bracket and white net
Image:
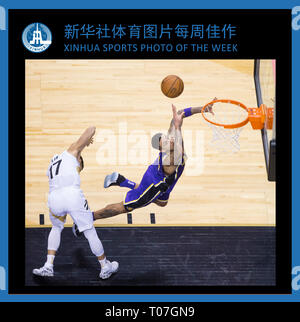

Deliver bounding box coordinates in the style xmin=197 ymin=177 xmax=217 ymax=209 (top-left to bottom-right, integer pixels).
xmin=201 ymin=99 xmax=273 ymax=152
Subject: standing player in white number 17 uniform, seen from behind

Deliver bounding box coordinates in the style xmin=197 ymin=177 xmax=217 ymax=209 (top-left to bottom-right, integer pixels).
xmin=33 ymin=127 xmax=119 ymax=279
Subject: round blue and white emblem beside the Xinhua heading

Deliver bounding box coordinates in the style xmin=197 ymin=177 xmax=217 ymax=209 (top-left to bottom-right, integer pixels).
xmin=22 ymin=23 xmax=52 ymax=53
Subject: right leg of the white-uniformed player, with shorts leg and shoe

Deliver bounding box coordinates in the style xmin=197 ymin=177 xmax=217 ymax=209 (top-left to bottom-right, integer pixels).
xmin=69 ymin=192 xmax=119 ymax=279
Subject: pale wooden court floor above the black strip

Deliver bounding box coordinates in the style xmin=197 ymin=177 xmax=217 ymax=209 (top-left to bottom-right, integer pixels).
xmin=25 ymin=60 xmax=275 ymax=227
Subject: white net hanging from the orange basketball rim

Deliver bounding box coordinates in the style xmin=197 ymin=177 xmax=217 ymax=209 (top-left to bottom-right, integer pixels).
xmin=205 ymin=102 xmax=248 ymax=152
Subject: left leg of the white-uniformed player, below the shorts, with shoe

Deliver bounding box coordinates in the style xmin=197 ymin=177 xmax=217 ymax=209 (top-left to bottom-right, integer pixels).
xmin=32 ymin=211 xmax=67 ymax=276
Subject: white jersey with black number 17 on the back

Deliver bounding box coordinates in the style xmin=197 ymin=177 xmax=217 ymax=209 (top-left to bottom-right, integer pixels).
xmin=47 ymin=151 xmax=80 ymax=192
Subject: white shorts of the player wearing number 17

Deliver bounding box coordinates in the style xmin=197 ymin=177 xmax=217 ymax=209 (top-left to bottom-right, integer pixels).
xmin=48 ymin=187 xmax=94 ymax=232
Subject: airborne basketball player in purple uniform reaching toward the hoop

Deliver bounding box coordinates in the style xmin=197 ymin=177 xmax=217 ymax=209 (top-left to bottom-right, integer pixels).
xmin=73 ymin=98 xmax=216 ymax=226
